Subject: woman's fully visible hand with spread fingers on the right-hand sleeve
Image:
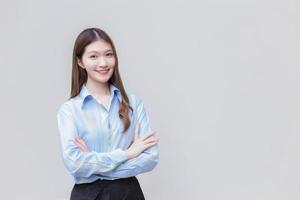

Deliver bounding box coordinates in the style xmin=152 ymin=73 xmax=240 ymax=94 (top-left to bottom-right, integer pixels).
xmin=125 ymin=123 xmax=159 ymax=159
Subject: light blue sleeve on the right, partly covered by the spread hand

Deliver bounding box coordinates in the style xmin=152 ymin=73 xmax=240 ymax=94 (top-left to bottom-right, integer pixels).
xmin=102 ymin=96 xmax=159 ymax=178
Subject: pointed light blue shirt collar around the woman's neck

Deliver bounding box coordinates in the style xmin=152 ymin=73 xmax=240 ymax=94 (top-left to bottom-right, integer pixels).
xmin=79 ymin=83 xmax=122 ymax=108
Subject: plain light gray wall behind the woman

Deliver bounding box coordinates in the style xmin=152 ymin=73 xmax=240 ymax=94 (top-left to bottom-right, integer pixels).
xmin=0 ymin=0 xmax=300 ymax=200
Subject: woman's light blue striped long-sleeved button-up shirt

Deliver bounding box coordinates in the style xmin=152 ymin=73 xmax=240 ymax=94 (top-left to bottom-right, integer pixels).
xmin=57 ymin=84 xmax=159 ymax=184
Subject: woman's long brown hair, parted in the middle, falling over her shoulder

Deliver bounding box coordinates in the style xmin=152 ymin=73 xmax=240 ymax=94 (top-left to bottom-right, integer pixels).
xmin=70 ymin=28 xmax=133 ymax=132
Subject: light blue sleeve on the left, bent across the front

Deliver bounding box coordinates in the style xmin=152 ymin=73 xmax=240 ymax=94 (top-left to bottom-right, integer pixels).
xmin=57 ymin=104 xmax=128 ymax=178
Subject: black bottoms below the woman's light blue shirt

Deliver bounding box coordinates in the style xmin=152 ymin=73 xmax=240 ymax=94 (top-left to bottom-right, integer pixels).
xmin=71 ymin=176 xmax=145 ymax=200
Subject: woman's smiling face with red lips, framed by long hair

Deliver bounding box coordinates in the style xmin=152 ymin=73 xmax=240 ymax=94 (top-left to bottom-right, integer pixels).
xmin=77 ymin=39 xmax=116 ymax=83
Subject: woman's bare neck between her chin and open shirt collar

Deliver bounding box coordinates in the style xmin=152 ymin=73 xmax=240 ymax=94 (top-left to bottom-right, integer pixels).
xmin=86 ymin=79 xmax=110 ymax=97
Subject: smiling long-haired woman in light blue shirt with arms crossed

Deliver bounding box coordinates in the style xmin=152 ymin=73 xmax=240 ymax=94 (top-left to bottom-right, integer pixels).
xmin=57 ymin=28 xmax=159 ymax=200
